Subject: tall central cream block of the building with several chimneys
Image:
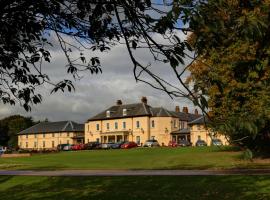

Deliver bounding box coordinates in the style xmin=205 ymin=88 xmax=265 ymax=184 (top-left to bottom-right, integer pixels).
xmin=85 ymin=97 xmax=201 ymax=145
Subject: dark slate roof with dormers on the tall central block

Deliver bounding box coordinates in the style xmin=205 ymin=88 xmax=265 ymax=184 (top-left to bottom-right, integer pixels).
xmin=88 ymin=103 xmax=201 ymax=121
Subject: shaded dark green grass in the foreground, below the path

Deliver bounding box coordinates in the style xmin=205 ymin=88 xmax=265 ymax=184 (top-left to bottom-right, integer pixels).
xmin=0 ymin=176 xmax=270 ymax=200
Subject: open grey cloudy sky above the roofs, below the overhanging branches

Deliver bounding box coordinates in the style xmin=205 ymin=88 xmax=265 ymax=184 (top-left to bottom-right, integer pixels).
xmin=0 ymin=24 xmax=194 ymax=123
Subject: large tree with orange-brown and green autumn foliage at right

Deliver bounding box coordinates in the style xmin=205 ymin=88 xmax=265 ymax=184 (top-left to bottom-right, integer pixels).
xmin=188 ymin=1 xmax=270 ymax=151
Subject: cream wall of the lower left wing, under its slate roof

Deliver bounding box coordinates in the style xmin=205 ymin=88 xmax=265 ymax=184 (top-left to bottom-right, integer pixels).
xmin=18 ymin=132 xmax=83 ymax=149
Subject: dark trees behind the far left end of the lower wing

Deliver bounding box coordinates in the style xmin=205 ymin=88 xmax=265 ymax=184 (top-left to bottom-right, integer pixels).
xmin=0 ymin=115 xmax=47 ymax=148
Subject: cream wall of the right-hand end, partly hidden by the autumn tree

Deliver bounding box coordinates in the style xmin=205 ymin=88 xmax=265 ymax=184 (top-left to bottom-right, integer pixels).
xmin=190 ymin=124 xmax=229 ymax=146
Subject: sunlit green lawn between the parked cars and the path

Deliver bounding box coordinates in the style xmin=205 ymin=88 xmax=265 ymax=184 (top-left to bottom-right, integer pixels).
xmin=0 ymin=147 xmax=270 ymax=170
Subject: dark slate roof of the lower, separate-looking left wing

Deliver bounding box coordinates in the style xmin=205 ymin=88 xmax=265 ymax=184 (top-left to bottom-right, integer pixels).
xmin=18 ymin=121 xmax=84 ymax=134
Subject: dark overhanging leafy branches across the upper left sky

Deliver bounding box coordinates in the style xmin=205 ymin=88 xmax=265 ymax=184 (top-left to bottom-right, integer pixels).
xmin=0 ymin=0 xmax=195 ymax=110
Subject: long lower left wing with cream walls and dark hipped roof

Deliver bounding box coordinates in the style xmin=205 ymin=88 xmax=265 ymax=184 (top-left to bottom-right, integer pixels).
xmin=18 ymin=121 xmax=84 ymax=150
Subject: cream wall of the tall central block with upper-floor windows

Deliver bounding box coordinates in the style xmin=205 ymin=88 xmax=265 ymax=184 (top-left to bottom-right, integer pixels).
xmin=85 ymin=116 xmax=180 ymax=145
